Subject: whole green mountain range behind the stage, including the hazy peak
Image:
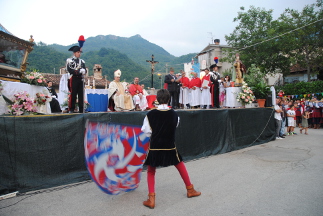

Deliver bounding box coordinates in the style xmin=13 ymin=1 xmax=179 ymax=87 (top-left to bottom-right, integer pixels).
xmin=28 ymin=35 xmax=196 ymax=86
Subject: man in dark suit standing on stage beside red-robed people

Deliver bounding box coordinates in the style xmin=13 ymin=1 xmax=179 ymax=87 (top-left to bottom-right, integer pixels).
xmin=164 ymin=68 xmax=180 ymax=109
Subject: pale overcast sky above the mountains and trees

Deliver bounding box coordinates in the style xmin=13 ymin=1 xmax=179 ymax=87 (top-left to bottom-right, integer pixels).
xmin=0 ymin=0 xmax=316 ymax=56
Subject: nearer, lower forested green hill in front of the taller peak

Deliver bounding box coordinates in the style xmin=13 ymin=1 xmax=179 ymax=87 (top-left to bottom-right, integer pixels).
xmin=28 ymin=43 xmax=150 ymax=84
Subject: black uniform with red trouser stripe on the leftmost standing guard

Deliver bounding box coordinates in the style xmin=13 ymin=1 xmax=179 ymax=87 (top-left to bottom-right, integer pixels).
xmin=66 ymin=56 xmax=86 ymax=113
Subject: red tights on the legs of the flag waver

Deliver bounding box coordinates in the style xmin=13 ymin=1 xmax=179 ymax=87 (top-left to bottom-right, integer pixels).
xmin=147 ymin=161 xmax=191 ymax=193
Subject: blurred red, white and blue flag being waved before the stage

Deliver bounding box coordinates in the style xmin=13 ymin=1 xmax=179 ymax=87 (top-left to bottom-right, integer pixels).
xmin=84 ymin=121 xmax=149 ymax=195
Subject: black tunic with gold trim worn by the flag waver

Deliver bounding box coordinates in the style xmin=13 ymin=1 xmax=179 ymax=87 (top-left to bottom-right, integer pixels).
xmin=145 ymin=109 xmax=182 ymax=167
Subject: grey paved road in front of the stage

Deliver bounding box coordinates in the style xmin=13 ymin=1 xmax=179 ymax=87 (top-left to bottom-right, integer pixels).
xmin=0 ymin=129 xmax=323 ymax=216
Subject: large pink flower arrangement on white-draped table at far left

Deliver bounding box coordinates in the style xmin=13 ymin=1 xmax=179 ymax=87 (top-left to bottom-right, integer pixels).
xmin=8 ymin=91 xmax=37 ymax=116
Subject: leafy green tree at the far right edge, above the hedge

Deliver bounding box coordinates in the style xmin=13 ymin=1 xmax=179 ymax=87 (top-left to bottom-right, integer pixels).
xmin=278 ymin=0 xmax=323 ymax=81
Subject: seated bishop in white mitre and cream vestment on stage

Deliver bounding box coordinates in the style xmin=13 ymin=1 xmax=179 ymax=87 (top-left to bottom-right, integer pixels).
xmin=108 ymin=69 xmax=135 ymax=111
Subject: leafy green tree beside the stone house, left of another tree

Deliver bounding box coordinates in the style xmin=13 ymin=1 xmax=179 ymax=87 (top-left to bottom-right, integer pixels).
xmin=225 ymin=6 xmax=289 ymax=76
